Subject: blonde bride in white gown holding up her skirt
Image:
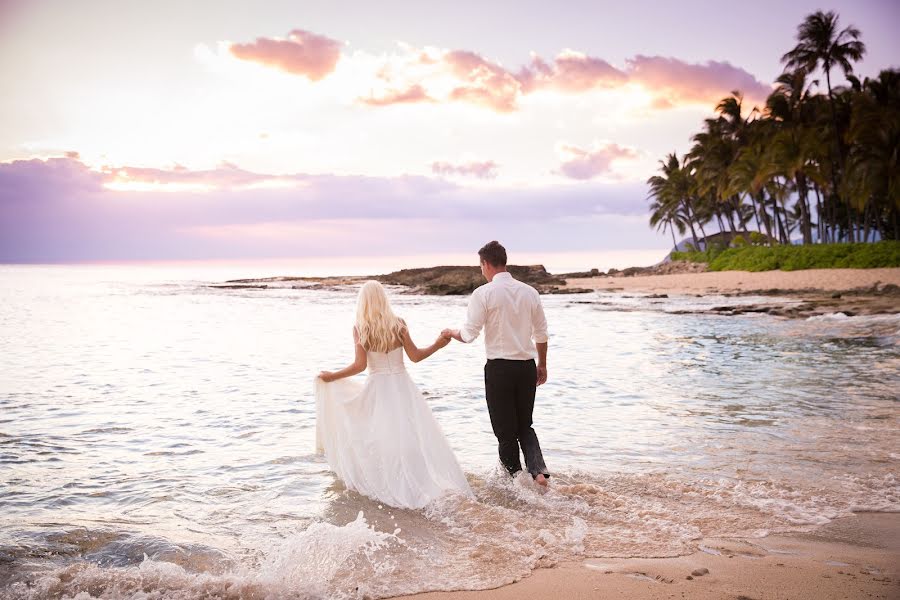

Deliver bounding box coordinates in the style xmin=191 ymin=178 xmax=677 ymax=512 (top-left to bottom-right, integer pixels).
xmin=316 ymin=281 xmax=472 ymax=508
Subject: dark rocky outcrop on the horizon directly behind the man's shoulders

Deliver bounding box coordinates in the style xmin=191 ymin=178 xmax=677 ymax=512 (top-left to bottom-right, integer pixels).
xmin=373 ymin=265 xmax=572 ymax=296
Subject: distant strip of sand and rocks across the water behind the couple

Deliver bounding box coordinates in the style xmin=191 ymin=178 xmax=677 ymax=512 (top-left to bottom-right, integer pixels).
xmin=209 ymin=265 xmax=900 ymax=318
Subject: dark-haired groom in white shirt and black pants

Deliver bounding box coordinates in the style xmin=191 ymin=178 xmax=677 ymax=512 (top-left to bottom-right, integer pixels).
xmin=443 ymin=241 xmax=550 ymax=486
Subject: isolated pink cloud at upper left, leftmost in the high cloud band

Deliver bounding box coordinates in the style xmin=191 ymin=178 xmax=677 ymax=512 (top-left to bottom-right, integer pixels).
xmin=230 ymin=29 xmax=341 ymax=81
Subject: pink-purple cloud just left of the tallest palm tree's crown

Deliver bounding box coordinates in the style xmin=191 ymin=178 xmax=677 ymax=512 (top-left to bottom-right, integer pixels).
xmin=627 ymin=55 xmax=772 ymax=108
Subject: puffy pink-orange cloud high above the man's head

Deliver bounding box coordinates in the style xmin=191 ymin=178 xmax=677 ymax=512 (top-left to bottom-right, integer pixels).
xmin=444 ymin=50 xmax=522 ymax=113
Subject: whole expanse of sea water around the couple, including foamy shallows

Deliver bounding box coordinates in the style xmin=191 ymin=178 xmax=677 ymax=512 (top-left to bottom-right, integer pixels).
xmin=0 ymin=266 xmax=900 ymax=598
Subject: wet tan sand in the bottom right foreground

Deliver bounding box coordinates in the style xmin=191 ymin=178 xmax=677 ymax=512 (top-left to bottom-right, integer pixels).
xmin=400 ymin=512 xmax=900 ymax=600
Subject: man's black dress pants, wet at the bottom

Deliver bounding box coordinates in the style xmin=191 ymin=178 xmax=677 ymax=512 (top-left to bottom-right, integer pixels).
xmin=484 ymin=359 xmax=548 ymax=477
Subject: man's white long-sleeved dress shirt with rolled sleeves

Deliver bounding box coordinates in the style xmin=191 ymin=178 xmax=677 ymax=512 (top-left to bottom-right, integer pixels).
xmin=459 ymin=272 xmax=547 ymax=360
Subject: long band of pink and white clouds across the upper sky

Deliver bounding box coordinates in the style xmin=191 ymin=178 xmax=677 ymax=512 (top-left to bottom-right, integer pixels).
xmin=221 ymin=29 xmax=771 ymax=114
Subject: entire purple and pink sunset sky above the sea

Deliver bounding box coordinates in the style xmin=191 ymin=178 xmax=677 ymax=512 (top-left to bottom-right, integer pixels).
xmin=0 ymin=0 xmax=900 ymax=268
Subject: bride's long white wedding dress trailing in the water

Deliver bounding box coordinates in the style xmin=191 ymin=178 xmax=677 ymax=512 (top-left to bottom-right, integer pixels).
xmin=316 ymin=348 xmax=472 ymax=508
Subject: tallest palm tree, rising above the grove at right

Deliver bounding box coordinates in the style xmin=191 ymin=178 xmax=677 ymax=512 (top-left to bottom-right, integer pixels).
xmin=781 ymin=11 xmax=866 ymax=223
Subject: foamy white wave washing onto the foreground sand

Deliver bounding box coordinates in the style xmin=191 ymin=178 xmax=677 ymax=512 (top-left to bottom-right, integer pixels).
xmin=0 ymin=469 xmax=900 ymax=600
